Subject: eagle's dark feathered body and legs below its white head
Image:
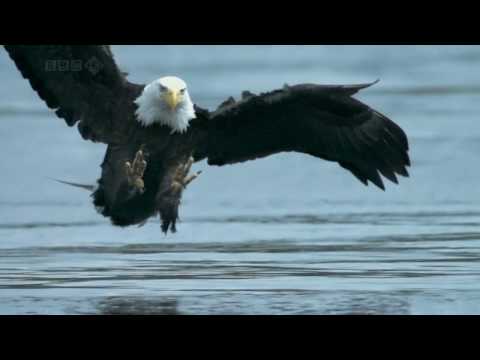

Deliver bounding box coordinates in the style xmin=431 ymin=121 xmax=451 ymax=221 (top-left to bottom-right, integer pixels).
xmin=92 ymin=131 xmax=200 ymax=229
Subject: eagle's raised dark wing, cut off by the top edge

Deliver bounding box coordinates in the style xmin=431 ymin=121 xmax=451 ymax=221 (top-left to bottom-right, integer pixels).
xmin=5 ymin=45 xmax=140 ymax=143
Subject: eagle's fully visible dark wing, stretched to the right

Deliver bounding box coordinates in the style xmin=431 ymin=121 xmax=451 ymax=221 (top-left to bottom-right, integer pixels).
xmin=196 ymin=80 xmax=410 ymax=189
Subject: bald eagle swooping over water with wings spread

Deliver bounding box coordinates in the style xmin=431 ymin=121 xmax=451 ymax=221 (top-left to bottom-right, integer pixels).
xmin=5 ymin=45 xmax=410 ymax=233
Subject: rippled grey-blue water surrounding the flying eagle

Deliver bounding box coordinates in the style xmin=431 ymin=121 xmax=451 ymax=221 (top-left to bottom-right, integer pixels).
xmin=0 ymin=46 xmax=480 ymax=314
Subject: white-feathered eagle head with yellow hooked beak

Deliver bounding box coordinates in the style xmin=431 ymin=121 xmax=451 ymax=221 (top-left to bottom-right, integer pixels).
xmin=135 ymin=76 xmax=195 ymax=133
